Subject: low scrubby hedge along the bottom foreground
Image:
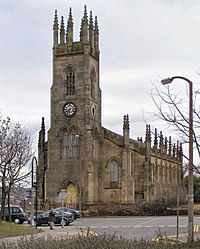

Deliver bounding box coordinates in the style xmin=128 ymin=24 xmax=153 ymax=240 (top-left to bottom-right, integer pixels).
xmin=0 ymin=234 xmax=200 ymax=249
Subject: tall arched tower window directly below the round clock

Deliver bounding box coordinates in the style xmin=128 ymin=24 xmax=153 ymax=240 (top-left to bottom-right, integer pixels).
xmin=61 ymin=129 xmax=79 ymax=159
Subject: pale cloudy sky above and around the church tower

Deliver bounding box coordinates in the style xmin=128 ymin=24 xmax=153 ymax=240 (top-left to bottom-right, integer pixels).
xmin=0 ymin=0 xmax=200 ymax=158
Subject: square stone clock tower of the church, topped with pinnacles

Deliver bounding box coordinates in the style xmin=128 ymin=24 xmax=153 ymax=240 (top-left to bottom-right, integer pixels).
xmin=45 ymin=6 xmax=101 ymax=207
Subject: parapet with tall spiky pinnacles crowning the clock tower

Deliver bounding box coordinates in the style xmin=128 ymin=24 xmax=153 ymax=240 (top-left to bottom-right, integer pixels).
xmin=53 ymin=6 xmax=99 ymax=59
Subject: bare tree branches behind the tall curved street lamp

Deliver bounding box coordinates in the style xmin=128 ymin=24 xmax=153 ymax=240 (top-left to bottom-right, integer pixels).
xmin=151 ymin=81 xmax=200 ymax=174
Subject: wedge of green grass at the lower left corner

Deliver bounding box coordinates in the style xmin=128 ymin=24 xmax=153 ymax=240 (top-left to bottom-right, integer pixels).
xmin=0 ymin=221 xmax=41 ymax=238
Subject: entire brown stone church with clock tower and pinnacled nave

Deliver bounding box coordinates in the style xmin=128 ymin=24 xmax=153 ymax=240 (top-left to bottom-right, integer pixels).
xmin=37 ymin=7 xmax=183 ymax=210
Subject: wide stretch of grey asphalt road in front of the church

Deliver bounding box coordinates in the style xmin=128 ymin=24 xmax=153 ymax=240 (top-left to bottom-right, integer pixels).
xmin=70 ymin=216 xmax=200 ymax=239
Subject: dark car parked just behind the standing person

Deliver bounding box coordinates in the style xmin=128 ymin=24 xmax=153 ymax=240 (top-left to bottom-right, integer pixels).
xmin=34 ymin=210 xmax=72 ymax=226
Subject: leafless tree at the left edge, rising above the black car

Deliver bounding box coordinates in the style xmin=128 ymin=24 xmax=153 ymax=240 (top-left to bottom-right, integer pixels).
xmin=0 ymin=115 xmax=32 ymax=222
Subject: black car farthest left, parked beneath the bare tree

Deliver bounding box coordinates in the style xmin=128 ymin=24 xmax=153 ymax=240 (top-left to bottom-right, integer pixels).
xmin=2 ymin=205 xmax=28 ymax=224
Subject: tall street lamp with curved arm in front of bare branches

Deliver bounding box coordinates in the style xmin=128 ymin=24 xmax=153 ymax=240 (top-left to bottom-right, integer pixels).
xmin=161 ymin=76 xmax=194 ymax=241
